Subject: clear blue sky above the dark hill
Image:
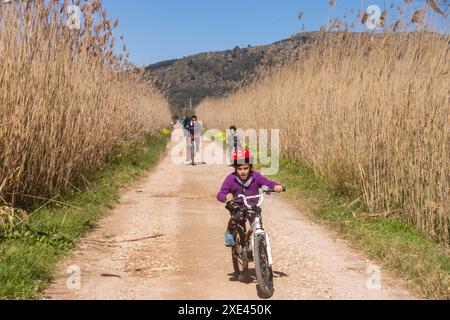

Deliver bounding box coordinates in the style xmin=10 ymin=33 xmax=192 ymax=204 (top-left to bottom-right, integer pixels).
xmin=103 ymin=0 xmax=448 ymax=66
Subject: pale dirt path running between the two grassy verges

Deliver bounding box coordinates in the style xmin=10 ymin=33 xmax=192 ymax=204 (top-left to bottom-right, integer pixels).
xmin=43 ymin=136 xmax=416 ymax=300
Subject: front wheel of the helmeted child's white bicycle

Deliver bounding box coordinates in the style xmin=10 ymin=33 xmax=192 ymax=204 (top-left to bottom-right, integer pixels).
xmin=253 ymin=236 xmax=275 ymax=299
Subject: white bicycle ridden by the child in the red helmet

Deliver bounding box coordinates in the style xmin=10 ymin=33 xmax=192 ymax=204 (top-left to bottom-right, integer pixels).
xmin=226 ymin=187 xmax=286 ymax=299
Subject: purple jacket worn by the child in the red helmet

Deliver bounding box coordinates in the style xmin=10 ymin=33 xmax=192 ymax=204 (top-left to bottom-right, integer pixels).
xmin=217 ymin=172 xmax=278 ymax=205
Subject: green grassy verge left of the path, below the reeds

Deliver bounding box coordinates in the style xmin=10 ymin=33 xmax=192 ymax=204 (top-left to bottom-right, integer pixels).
xmin=0 ymin=131 xmax=167 ymax=299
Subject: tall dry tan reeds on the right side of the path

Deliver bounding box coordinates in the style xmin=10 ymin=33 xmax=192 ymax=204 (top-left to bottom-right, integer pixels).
xmin=197 ymin=3 xmax=450 ymax=245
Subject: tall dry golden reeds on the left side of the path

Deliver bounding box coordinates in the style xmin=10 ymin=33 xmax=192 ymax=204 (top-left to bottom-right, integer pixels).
xmin=0 ymin=0 xmax=170 ymax=203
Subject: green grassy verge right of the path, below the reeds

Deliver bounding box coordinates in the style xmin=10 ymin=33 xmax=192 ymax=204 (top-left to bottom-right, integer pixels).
xmin=276 ymin=161 xmax=450 ymax=299
